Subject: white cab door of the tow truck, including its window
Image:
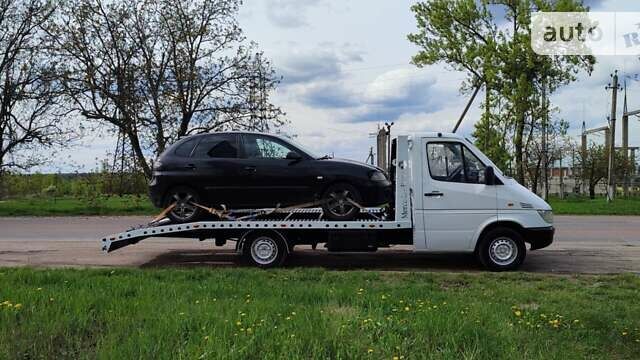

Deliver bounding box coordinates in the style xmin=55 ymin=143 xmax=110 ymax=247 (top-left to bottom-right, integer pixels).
xmin=419 ymin=138 xmax=497 ymax=251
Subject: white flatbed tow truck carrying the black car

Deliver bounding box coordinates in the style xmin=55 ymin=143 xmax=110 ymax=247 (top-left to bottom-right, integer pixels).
xmin=101 ymin=133 xmax=554 ymax=271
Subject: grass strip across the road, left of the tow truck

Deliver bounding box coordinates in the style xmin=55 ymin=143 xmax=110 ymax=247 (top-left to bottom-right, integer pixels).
xmin=0 ymin=196 xmax=159 ymax=216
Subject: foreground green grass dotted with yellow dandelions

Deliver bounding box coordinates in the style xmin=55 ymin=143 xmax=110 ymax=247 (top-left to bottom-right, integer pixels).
xmin=0 ymin=268 xmax=640 ymax=359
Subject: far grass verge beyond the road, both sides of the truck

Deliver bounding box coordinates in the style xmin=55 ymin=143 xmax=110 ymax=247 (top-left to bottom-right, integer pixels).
xmin=0 ymin=195 xmax=640 ymax=216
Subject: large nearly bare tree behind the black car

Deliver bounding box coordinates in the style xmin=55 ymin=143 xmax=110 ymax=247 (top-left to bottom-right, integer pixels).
xmin=55 ymin=0 xmax=282 ymax=176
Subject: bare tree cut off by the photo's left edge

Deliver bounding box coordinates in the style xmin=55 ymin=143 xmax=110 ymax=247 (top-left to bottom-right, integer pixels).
xmin=0 ymin=0 xmax=66 ymax=175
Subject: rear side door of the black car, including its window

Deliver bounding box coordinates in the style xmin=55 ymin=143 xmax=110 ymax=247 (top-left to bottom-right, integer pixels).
xmin=191 ymin=134 xmax=242 ymax=207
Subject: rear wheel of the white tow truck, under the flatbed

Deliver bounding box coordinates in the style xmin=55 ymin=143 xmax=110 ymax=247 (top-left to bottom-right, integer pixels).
xmin=242 ymin=231 xmax=289 ymax=269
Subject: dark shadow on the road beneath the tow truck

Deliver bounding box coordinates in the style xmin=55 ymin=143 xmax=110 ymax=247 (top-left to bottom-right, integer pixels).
xmin=141 ymin=249 xmax=483 ymax=271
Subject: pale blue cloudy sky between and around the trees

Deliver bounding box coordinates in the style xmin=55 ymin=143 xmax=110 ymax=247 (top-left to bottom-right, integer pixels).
xmin=43 ymin=0 xmax=640 ymax=171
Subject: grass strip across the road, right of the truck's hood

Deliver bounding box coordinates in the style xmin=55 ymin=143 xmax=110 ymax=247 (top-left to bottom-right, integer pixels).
xmin=549 ymin=198 xmax=640 ymax=215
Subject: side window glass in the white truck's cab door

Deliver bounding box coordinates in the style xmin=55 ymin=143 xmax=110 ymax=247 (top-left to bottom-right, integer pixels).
xmin=427 ymin=142 xmax=486 ymax=184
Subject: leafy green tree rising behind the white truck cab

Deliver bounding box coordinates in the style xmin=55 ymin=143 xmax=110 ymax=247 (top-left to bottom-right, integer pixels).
xmin=408 ymin=0 xmax=595 ymax=184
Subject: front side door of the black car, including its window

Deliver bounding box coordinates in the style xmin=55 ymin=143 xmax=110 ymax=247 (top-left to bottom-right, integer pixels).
xmin=242 ymin=134 xmax=313 ymax=207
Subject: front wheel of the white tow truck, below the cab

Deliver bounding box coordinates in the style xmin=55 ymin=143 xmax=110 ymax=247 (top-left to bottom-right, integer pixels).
xmin=477 ymin=227 xmax=527 ymax=271
